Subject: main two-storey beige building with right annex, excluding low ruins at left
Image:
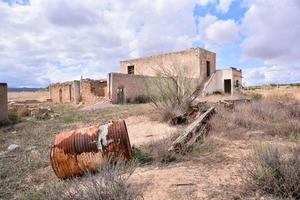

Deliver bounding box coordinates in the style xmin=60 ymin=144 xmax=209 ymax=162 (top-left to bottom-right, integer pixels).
xmin=108 ymin=48 xmax=242 ymax=103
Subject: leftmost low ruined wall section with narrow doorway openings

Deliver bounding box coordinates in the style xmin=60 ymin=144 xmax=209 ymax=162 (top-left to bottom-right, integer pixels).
xmin=49 ymin=82 xmax=74 ymax=103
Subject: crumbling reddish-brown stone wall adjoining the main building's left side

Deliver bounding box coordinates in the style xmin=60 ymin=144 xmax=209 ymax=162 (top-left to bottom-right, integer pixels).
xmin=80 ymin=79 xmax=107 ymax=104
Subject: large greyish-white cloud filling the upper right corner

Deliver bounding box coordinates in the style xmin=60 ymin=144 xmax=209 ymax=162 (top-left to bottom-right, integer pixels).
xmin=242 ymin=0 xmax=300 ymax=65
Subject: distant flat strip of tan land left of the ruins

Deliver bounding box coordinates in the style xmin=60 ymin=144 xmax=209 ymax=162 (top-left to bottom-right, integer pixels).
xmin=8 ymin=91 xmax=49 ymax=102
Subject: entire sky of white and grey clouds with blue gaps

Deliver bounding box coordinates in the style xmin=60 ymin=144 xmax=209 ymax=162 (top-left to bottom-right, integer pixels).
xmin=0 ymin=0 xmax=300 ymax=87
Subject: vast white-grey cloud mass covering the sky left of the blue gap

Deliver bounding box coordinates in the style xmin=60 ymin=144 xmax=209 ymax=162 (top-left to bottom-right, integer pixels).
xmin=0 ymin=0 xmax=198 ymax=86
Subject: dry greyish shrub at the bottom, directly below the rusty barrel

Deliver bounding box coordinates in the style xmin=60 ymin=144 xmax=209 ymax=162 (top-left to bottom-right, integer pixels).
xmin=44 ymin=163 xmax=143 ymax=200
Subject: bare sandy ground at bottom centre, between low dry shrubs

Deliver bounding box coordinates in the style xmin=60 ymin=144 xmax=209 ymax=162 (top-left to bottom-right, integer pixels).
xmin=131 ymin=137 xmax=252 ymax=200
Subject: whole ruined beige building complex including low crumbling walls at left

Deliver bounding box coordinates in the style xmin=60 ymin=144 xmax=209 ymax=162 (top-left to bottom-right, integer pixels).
xmin=49 ymin=48 xmax=242 ymax=104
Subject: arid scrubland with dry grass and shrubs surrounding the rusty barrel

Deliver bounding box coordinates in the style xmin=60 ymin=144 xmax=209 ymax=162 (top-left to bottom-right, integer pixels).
xmin=0 ymin=86 xmax=300 ymax=200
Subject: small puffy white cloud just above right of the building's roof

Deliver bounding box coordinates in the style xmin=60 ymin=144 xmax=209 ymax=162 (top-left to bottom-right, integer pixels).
xmin=205 ymin=20 xmax=238 ymax=44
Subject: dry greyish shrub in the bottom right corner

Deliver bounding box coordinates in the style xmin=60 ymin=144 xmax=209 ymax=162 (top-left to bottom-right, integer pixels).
xmin=243 ymin=145 xmax=300 ymax=199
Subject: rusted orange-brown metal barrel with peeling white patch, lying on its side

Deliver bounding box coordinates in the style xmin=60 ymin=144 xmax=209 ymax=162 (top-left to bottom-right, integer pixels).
xmin=50 ymin=121 xmax=132 ymax=178
